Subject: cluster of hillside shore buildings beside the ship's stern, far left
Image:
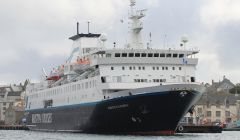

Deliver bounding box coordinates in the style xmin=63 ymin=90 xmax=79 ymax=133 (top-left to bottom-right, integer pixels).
xmin=0 ymin=84 xmax=25 ymax=125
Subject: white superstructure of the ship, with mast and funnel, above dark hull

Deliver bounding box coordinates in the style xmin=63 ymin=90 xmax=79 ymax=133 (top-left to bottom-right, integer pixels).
xmin=26 ymin=0 xmax=198 ymax=110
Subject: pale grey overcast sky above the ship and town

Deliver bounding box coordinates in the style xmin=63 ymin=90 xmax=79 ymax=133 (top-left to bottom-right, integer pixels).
xmin=0 ymin=0 xmax=240 ymax=84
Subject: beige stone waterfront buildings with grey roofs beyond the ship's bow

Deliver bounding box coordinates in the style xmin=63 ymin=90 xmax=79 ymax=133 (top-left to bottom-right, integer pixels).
xmin=183 ymin=76 xmax=240 ymax=124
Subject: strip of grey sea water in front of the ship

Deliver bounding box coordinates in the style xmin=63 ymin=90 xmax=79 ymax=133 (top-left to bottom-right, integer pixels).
xmin=0 ymin=130 xmax=240 ymax=140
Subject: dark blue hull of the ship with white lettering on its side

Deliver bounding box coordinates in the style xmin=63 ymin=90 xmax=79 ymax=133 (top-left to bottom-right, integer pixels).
xmin=27 ymin=91 xmax=202 ymax=134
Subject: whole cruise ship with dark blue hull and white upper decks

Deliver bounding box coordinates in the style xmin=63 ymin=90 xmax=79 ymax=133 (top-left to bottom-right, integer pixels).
xmin=25 ymin=0 xmax=205 ymax=134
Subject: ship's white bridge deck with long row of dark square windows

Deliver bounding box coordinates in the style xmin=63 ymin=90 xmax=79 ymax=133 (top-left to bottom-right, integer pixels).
xmin=83 ymin=49 xmax=199 ymax=66
